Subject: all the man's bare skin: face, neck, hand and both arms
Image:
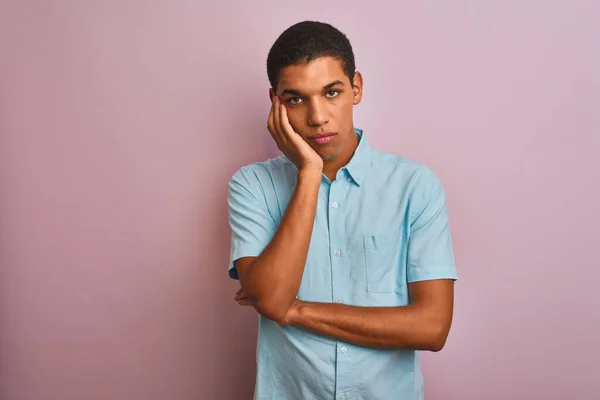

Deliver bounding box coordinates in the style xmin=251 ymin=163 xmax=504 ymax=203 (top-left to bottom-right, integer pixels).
xmin=234 ymin=57 xmax=454 ymax=351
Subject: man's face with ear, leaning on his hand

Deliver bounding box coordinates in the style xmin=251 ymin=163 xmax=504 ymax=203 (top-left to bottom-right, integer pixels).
xmin=270 ymin=57 xmax=362 ymax=161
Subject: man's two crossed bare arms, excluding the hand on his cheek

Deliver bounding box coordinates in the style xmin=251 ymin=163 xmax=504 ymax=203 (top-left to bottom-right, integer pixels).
xmin=234 ymin=167 xmax=454 ymax=351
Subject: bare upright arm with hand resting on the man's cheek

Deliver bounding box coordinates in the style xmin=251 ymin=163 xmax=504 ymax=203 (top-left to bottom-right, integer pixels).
xmin=236 ymin=97 xmax=323 ymax=321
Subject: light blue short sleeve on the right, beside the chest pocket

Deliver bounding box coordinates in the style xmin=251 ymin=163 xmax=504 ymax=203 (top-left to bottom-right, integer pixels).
xmin=407 ymin=167 xmax=458 ymax=283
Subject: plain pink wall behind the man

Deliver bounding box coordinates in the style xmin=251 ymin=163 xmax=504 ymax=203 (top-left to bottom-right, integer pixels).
xmin=0 ymin=0 xmax=600 ymax=400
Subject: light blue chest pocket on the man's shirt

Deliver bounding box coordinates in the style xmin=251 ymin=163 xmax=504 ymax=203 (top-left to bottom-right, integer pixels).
xmin=363 ymin=232 xmax=407 ymax=293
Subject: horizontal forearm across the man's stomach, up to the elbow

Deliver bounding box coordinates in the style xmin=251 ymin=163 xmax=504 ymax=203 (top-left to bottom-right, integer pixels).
xmin=287 ymin=301 xmax=449 ymax=351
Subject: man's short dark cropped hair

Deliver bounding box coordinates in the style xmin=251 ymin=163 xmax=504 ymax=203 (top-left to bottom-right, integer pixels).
xmin=267 ymin=21 xmax=356 ymax=89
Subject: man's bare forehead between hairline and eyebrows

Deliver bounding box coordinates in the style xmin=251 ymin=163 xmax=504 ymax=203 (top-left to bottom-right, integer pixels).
xmin=277 ymin=57 xmax=350 ymax=92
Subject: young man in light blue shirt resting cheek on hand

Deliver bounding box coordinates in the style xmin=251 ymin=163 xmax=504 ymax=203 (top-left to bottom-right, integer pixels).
xmin=228 ymin=22 xmax=457 ymax=400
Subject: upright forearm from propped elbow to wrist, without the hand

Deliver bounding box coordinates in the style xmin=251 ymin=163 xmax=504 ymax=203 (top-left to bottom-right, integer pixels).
xmin=242 ymin=172 xmax=322 ymax=319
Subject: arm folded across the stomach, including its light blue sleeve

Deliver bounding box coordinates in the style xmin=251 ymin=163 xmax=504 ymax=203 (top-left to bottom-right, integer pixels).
xmin=235 ymin=166 xmax=457 ymax=351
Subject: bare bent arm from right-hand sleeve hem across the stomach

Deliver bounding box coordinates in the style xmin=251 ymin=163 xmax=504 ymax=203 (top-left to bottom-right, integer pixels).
xmin=282 ymin=279 xmax=454 ymax=351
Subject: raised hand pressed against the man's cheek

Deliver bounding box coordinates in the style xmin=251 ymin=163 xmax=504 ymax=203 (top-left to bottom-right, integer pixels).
xmin=267 ymin=96 xmax=323 ymax=173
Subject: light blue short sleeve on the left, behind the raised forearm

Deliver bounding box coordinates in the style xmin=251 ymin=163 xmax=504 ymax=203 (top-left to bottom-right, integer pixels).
xmin=227 ymin=168 xmax=277 ymax=279
